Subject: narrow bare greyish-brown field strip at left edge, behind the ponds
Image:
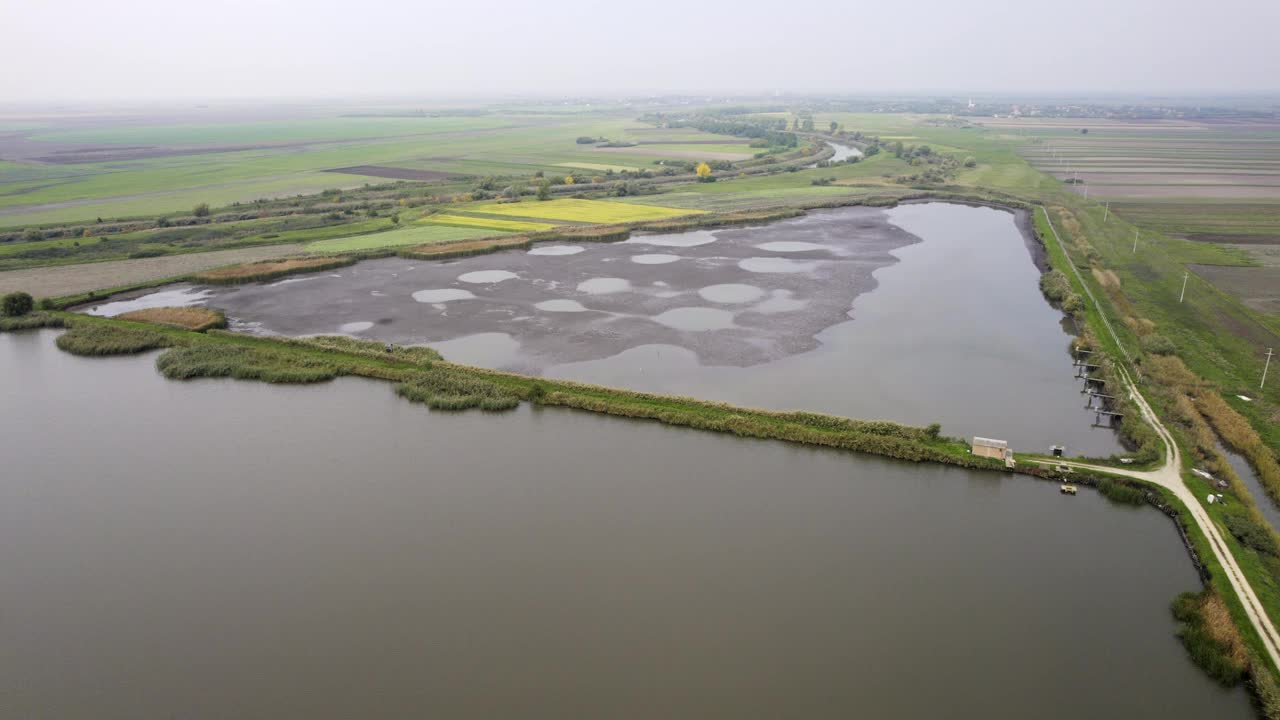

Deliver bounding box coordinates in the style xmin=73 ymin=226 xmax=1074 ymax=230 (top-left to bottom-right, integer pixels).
xmin=0 ymin=245 xmax=302 ymax=297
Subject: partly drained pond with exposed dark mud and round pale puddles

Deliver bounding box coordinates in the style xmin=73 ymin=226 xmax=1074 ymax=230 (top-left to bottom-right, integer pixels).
xmin=96 ymin=202 xmax=1123 ymax=456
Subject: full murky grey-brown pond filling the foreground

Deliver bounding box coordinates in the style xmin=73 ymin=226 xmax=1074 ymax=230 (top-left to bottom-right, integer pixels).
xmin=0 ymin=331 xmax=1251 ymax=720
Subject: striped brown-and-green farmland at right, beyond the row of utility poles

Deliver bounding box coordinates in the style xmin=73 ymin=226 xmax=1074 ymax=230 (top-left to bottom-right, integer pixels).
xmin=983 ymin=119 xmax=1280 ymax=313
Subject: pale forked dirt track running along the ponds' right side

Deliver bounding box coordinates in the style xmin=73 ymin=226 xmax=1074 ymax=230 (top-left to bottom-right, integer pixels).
xmin=1041 ymin=206 xmax=1280 ymax=667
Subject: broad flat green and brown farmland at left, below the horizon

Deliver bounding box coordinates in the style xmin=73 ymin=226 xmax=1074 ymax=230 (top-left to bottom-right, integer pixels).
xmin=0 ymin=111 xmax=755 ymax=228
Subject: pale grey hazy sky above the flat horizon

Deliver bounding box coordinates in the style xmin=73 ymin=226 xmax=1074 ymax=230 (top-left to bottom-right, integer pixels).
xmin=0 ymin=0 xmax=1280 ymax=101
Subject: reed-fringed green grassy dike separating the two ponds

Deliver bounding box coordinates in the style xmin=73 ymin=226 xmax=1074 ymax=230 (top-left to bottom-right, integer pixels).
xmin=27 ymin=311 xmax=1004 ymax=470
